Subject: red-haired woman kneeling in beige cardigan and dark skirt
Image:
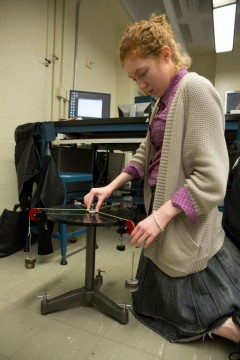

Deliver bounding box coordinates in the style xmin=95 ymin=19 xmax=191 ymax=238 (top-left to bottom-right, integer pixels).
xmin=85 ymin=15 xmax=240 ymax=342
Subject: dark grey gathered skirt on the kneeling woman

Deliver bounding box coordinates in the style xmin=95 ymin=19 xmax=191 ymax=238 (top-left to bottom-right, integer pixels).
xmin=133 ymin=238 xmax=240 ymax=342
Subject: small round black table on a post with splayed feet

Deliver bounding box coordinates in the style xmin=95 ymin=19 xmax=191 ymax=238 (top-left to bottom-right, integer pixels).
xmin=41 ymin=205 xmax=128 ymax=324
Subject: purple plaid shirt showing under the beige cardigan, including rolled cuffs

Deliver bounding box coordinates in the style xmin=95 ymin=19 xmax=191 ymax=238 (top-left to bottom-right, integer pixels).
xmin=123 ymin=68 xmax=196 ymax=223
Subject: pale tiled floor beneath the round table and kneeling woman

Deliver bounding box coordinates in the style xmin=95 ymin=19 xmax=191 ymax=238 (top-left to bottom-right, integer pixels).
xmin=0 ymin=228 xmax=236 ymax=360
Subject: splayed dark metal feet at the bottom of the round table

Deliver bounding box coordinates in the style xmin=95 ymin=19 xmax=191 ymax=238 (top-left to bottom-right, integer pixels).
xmin=41 ymin=287 xmax=128 ymax=324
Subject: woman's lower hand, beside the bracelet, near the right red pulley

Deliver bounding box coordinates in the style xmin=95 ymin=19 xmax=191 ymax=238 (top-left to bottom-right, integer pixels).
xmin=131 ymin=215 xmax=161 ymax=248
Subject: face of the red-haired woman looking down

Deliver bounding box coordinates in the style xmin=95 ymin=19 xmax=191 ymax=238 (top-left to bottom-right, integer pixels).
xmin=123 ymin=48 xmax=175 ymax=98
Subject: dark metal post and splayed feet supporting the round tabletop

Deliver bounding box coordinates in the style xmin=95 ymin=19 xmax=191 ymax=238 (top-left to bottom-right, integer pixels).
xmin=41 ymin=228 xmax=128 ymax=324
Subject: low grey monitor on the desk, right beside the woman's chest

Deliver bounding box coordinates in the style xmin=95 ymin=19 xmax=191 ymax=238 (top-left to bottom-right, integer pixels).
xmin=118 ymin=102 xmax=152 ymax=117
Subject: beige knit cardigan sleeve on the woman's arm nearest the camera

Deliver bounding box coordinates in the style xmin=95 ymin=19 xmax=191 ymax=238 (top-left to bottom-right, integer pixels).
xmin=183 ymin=76 xmax=229 ymax=214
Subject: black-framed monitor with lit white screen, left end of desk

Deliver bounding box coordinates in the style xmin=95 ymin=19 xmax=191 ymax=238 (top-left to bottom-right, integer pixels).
xmin=69 ymin=90 xmax=111 ymax=119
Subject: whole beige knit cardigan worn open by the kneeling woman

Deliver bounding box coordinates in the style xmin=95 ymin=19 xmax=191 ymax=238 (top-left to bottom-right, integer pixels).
xmin=131 ymin=73 xmax=229 ymax=277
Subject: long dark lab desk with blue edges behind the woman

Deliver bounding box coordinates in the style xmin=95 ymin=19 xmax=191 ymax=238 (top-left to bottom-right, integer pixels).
xmin=37 ymin=114 xmax=240 ymax=193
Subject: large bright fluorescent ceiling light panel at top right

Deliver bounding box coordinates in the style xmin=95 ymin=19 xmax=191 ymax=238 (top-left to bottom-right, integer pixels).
xmin=213 ymin=4 xmax=236 ymax=53
